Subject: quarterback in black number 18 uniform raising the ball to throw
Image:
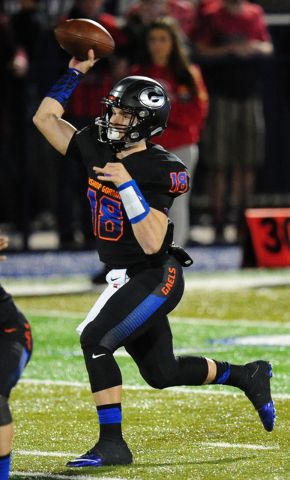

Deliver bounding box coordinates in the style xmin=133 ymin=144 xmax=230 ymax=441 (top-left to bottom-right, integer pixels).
xmin=34 ymin=50 xmax=275 ymax=467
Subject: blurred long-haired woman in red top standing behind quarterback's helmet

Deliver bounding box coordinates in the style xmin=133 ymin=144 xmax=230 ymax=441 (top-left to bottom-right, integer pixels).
xmin=132 ymin=17 xmax=208 ymax=247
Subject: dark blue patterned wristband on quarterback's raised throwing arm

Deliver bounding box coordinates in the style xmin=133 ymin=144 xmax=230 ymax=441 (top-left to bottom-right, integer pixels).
xmin=46 ymin=68 xmax=84 ymax=108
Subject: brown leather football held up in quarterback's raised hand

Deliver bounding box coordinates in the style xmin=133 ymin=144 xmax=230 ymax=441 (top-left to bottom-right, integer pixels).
xmin=54 ymin=18 xmax=115 ymax=61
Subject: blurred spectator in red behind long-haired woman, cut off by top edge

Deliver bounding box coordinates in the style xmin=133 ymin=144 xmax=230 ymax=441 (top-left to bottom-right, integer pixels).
xmin=124 ymin=0 xmax=195 ymax=64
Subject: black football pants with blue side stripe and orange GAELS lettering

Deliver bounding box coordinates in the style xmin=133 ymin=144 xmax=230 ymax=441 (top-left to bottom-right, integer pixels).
xmin=81 ymin=255 xmax=207 ymax=392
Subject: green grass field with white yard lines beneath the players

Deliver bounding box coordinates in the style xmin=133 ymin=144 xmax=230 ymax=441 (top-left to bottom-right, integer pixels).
xmin=4 ymin=272 xmax=290 ymax=480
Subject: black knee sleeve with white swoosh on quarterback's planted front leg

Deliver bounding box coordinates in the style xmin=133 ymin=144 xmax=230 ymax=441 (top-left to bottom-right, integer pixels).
xmin=83 ymin=345 xmax=122 ymax=393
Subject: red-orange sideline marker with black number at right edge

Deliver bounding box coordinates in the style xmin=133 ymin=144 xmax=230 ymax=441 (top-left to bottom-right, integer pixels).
xmin=245 ymin=208 xmax=290 ymax=267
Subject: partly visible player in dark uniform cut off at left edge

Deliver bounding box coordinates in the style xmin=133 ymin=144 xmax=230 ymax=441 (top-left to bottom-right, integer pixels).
xmin=0 ymin=237 xmax=32 ymax=480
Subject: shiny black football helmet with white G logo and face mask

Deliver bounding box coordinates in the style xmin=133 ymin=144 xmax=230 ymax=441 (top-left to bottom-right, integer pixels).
xmin=95 ymin=76 xmax=171 ymax=151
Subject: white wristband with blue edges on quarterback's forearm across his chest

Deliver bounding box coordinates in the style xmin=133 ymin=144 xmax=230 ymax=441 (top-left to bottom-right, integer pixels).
xmin=117 ymin=180 xmax=150 ymax=224
